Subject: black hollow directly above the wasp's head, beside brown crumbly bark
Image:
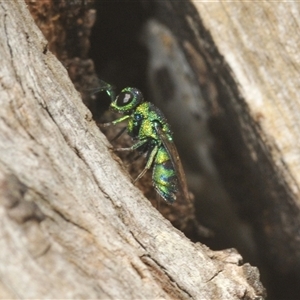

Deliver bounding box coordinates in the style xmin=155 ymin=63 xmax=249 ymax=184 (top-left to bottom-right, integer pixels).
xmin=89 ymin=0 xmax=152 ymax=115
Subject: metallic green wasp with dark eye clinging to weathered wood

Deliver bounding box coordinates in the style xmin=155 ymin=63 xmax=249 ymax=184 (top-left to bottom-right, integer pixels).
xmin=99 ymin=82 xmax=189 ymax=204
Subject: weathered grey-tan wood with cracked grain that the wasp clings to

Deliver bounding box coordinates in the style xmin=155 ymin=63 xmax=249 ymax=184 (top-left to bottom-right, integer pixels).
xmin=0 ymin=0 xmax=263 ymax=299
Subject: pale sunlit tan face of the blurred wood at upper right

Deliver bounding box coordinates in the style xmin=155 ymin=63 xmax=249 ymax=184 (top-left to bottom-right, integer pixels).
xmin=195 ymin=1 xmax=300 ymax=197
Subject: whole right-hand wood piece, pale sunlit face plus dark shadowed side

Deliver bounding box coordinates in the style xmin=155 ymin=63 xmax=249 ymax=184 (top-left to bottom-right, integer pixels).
xmin=188 ymin=1 xmax=300 ymax=298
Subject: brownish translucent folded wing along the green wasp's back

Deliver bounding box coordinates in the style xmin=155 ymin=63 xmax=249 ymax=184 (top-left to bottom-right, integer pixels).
xmin=155 ymin=123 xmax=190 ymax=201
